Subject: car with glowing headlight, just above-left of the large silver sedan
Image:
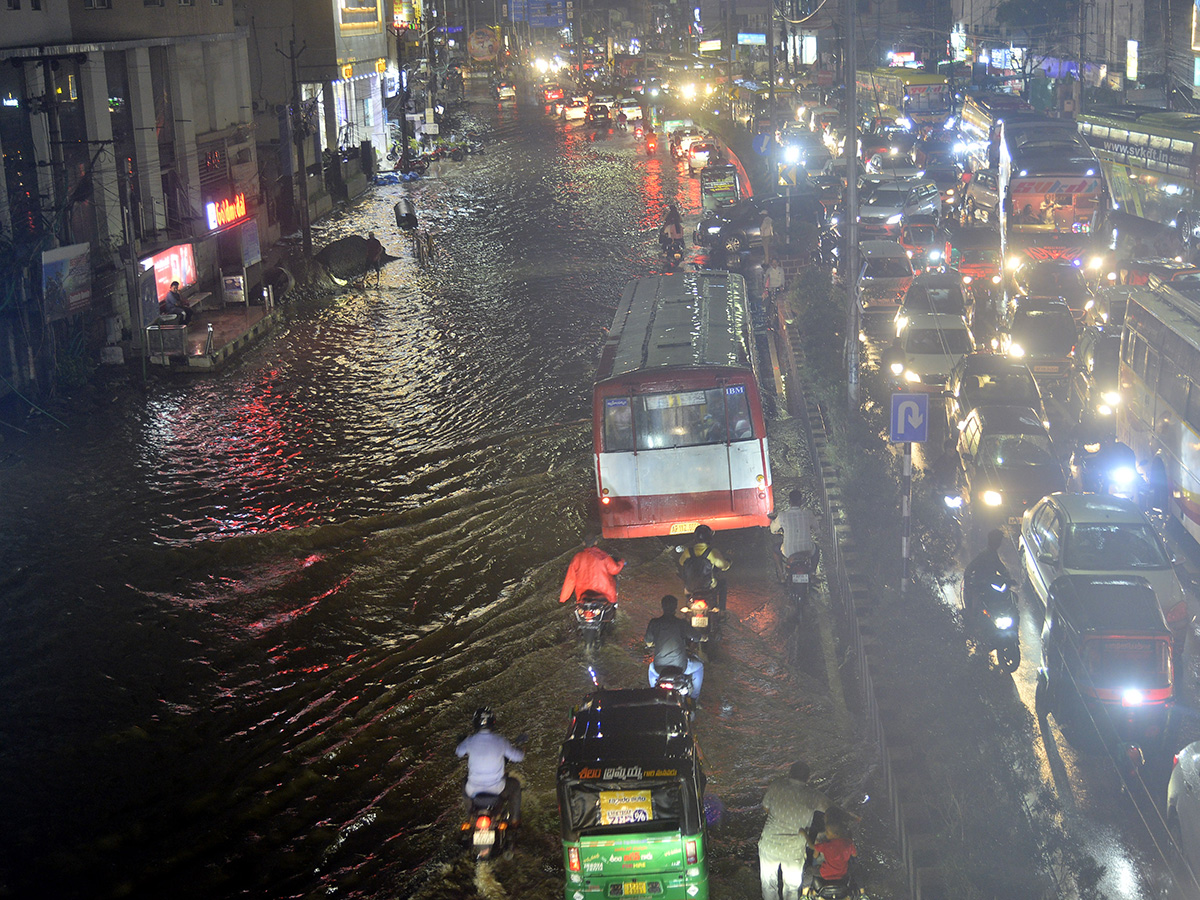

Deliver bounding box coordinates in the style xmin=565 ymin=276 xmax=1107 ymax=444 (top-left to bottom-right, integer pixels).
xmin=959 ymin=404 xmax=1067 ymax=533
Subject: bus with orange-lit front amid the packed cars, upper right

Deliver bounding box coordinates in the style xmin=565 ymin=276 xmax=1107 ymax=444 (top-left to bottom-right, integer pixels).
xmin=997 ymin=116 xmax=1109 ymax=289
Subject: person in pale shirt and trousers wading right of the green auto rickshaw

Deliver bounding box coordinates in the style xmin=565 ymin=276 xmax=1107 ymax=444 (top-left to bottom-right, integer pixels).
xmin=758 ymin=762 xmax=833 ymax=900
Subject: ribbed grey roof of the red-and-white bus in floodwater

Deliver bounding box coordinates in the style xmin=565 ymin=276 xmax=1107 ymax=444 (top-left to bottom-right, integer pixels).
xmin=596 ymin=271 xmax=754 ymax=380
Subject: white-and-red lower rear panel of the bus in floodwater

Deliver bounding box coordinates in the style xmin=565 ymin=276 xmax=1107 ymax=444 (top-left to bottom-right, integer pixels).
xmin=596 ymin=438 xmax=774 ymax=538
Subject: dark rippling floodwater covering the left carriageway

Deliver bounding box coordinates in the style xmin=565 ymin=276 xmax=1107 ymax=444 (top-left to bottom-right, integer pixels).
xmin=0 ymin=88 xmax=895 ymax=898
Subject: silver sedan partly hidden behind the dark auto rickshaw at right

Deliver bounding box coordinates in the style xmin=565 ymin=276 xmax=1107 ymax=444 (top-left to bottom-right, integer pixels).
xmin=1018 ymin=493 xmax=1193 ymax=649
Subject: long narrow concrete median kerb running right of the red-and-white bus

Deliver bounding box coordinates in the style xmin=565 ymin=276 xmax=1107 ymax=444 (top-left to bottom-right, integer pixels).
xmin=779 ymin=312 xmax=946 ymax=900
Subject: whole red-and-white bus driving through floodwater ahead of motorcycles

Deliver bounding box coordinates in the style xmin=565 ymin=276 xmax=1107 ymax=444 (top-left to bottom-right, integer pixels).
xmin=593 ymin=271 xmax=774 ymax=538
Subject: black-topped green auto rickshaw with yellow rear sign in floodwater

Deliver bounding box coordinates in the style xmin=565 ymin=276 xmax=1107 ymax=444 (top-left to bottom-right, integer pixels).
xmin=558 ymin=688 xmax=708 ymax=900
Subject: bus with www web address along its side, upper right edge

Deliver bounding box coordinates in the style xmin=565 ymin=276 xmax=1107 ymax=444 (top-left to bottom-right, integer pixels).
xmin=1079 ymin=107 xmax=1200 ymax=236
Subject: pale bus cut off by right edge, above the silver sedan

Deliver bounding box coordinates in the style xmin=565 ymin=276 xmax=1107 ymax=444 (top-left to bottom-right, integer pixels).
xmin=1116 ymin=276 xmax=1200 ymax=541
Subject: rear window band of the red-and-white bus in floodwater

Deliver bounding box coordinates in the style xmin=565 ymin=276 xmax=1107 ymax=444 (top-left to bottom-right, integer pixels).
xmin=604 ymin=384 xmax=757 ymax=452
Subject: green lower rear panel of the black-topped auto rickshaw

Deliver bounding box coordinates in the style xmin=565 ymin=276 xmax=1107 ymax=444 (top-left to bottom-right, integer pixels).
xmin=563 ymin=832 xmax=708 ymax=900
